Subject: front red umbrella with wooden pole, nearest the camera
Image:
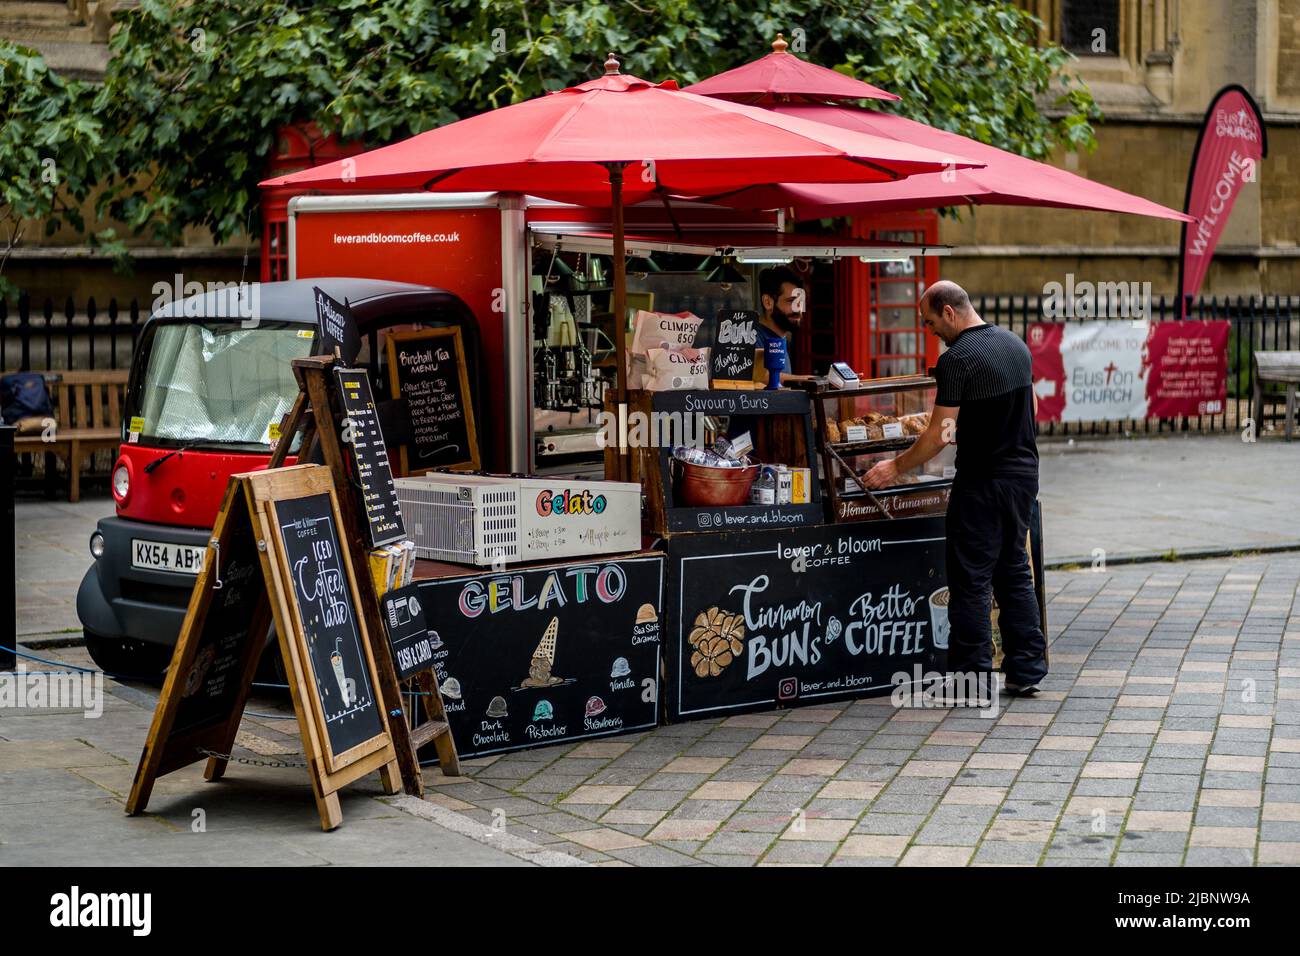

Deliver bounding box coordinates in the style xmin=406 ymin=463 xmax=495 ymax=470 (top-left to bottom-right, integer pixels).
xmin=261 ymin=55 xmax=978 ymax=416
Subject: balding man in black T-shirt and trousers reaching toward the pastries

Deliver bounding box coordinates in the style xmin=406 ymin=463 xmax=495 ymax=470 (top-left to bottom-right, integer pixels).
xmin=865 ymin=281 xmax=1048 ymax=696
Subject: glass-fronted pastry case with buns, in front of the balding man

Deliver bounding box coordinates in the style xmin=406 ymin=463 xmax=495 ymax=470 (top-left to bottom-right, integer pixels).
xmin=813 ymin=375 xmax=957 ymax=522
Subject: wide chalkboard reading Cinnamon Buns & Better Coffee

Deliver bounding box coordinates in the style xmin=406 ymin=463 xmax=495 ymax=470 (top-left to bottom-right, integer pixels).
xmin=664 ymin=516 xmax=948 ymax=719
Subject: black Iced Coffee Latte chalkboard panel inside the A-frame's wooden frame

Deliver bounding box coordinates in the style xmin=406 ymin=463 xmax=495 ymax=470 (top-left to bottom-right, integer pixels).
xmin=276 ymin=494 xmax=385 ymax=756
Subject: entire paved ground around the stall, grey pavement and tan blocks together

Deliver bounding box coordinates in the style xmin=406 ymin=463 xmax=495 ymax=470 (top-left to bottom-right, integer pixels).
xmin=0 ymin=438 xmax=1300 ymax=865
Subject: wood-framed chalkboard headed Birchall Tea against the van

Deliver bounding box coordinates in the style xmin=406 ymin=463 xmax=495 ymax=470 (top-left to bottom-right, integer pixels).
xmin=387 ymin=328 xmax=478 ymax=475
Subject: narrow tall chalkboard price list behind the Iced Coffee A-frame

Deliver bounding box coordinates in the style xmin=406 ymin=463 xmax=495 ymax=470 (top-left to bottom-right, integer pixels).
xmin=334 ymin=368 xmax=406 ymax=548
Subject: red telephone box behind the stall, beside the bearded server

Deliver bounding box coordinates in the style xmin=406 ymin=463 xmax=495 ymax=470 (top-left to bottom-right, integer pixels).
xmin=835 ymin=211 xmax=939 ymax=377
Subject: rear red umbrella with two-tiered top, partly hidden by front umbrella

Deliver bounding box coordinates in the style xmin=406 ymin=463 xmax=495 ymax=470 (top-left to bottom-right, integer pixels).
xmin=686 ymin=38 xmax=1191 ymax=221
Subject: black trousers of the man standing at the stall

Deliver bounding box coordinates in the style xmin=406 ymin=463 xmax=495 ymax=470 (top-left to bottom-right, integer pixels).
xmin=946 ymin=473 xmax=1048 ymax=684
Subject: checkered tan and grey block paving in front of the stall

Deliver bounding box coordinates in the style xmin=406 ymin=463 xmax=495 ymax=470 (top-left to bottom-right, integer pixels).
xmin=416 ymin=554 xmax=1300 ymax=866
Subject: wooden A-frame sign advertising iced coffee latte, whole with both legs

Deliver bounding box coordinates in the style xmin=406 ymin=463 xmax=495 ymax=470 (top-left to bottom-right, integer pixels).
xmin=126 ymin=464 xmax=400 ymax=830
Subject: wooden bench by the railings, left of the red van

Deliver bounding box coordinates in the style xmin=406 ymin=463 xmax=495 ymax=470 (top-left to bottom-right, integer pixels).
xmin=13 ymin=369 xmax=127 ymax=501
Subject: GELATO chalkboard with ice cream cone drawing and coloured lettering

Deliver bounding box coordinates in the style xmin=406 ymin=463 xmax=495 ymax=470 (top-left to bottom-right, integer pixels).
xmin=417 ymin=554 xmax=663 ymax=757
